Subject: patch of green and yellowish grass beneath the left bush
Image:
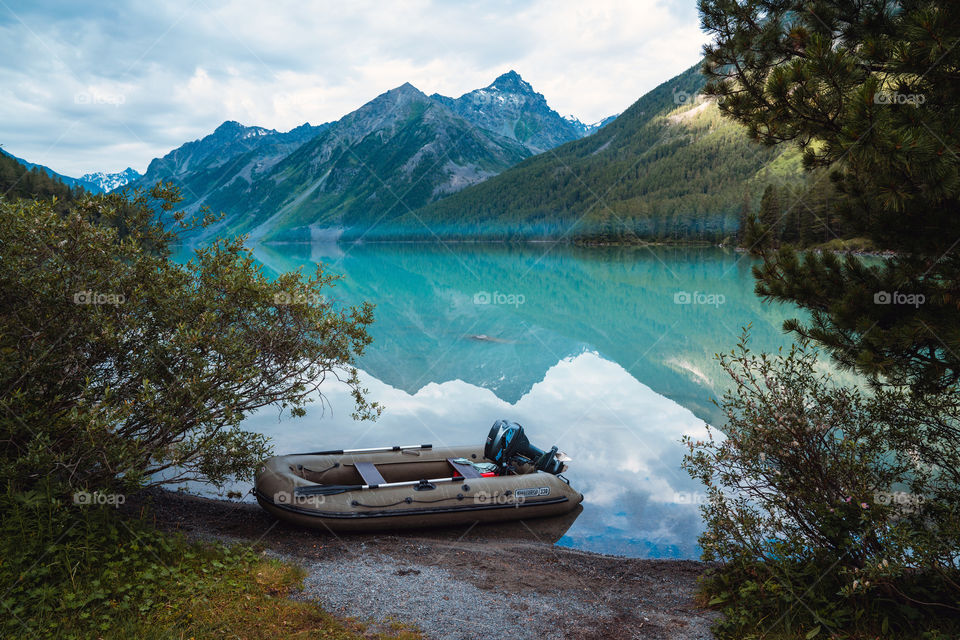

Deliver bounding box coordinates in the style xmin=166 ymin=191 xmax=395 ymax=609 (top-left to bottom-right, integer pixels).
xmin=0 ymin=489 xmax=422 ymax=640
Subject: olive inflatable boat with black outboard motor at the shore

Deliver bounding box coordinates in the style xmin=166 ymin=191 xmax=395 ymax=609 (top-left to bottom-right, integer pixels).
xmin=254 ymin=420 xmax=583 ymax=531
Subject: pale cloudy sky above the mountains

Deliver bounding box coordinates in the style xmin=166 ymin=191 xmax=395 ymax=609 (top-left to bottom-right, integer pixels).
xmin=0 ymin=0 xmax=707 ymax=177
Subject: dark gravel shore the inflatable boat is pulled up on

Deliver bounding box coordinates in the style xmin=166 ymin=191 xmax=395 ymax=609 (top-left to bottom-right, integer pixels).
xmin=135 ymin=491 xmax=714 ymax=640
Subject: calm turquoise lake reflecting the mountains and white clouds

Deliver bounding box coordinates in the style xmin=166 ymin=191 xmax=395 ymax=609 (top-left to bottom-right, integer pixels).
xmin=177 ymin=244 xmax=796 ymax=558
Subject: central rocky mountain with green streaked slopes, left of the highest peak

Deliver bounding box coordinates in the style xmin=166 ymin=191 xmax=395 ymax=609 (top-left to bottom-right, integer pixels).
xmin=190 ymin=83 xmax=530 ymax=240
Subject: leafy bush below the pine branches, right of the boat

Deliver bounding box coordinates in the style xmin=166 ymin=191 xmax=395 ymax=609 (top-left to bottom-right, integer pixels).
xmin=684 ymin=336 xmax=960 ymax=638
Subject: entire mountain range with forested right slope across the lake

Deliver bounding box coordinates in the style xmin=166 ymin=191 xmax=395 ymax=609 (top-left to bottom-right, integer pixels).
xmin=138 ymin=64 xmax=802 ymax=242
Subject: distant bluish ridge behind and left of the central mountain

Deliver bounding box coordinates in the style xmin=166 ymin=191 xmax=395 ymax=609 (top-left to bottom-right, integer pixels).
xmin=131 ymin=120 xmax=329 ymax=216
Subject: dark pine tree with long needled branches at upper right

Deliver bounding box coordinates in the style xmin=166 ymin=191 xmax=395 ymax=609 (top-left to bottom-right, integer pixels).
xmin=699 ymin=0 xmax=960 ymax=391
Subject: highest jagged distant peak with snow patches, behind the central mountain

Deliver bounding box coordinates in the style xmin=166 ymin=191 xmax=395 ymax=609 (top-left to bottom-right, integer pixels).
xmin=430 ymin=70 xmax=612 ymax=153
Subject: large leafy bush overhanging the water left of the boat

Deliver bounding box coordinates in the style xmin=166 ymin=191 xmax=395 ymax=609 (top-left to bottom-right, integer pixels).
xmin=0 ymin=187 xmax=379 ymax=490
